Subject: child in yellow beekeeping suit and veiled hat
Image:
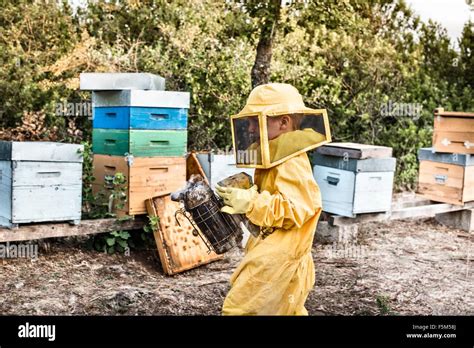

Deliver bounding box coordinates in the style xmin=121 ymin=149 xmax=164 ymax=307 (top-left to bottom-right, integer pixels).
xmin=216 ymin=83 xmax=331 ymax=315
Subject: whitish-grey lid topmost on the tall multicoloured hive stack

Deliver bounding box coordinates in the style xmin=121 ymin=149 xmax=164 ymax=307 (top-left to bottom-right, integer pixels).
xmin=80 ymin=73 xmax=165 ymax=91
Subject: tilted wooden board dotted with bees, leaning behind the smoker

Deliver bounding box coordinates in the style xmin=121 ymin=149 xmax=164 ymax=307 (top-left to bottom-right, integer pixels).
xmin=146 ymin=195 xmax=223 ymax=275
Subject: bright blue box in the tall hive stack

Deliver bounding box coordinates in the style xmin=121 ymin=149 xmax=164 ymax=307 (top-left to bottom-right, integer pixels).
xmin=93 ymin=106 xmax=188 ymax=130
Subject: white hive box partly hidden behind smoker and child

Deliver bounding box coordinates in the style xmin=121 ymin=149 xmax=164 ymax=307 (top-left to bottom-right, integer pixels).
xmin=197 ymin=153 xmax=254 ymax=187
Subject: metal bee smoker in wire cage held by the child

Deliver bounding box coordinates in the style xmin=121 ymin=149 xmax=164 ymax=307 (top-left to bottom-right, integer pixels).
xmin=171 ymin=175 xmax=242 ymax=254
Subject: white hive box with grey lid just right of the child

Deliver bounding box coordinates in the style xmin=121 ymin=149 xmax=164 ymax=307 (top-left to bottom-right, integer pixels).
xmin=312 ymin=143 xmax=396 ymax=217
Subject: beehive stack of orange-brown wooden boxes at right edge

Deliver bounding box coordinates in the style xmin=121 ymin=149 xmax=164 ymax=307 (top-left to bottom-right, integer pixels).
xmin=418 ymin=108 xmax=474 ymax=204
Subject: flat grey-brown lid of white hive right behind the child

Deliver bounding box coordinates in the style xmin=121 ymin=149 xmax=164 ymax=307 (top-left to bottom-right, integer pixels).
xmin=316 ymin=143 xmax=392 ymax=159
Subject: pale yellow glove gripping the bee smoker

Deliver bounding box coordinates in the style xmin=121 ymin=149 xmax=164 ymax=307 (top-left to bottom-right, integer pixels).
xmin=216 ymin=185 xmax=258 ymax=214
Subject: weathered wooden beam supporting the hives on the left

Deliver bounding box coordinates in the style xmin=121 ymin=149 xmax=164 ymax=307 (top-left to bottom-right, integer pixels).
xmin=0 ymin=217 xmax=146 ymax=243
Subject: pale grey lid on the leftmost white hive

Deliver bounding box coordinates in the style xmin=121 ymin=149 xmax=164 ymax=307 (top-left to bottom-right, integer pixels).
xmin=0 ymin=141 xmax=84 ymax=163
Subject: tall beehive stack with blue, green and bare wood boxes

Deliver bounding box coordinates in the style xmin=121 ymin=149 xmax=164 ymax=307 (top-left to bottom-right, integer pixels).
xmin=81 ymin=74 xmax=189 ymax=215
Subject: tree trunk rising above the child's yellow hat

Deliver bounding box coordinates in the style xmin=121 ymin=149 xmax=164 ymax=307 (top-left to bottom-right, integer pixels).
xmin=251 ymin=0 xmax=281 ymax=88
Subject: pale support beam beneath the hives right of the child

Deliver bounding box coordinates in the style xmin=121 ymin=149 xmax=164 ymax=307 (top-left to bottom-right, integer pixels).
xmin=322 ymin=194 xmax=474 ymax=226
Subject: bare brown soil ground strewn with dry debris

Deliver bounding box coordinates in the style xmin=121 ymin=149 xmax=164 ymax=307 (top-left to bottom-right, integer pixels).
xmin=0 ymin=219 xmax=474 ymax=315
